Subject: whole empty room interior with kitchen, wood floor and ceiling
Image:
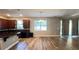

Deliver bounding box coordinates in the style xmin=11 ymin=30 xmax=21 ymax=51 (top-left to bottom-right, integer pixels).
xmin=0 ymin=9 xmax=79 ymax=50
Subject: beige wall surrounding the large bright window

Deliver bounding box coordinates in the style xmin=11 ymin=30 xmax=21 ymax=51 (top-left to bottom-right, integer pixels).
xmin=30 ymin=18 xmax=60 ymax=36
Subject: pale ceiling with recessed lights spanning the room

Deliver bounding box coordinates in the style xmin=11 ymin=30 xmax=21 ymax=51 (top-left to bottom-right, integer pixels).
xmin=0 ymin=9 xmax=79 ymax=17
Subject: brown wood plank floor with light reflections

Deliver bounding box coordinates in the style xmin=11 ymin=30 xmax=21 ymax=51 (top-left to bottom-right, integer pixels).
xmin=11 ymin=37 xmax=79 ymax=50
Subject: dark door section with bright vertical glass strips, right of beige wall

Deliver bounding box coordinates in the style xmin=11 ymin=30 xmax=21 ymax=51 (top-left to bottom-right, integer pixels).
xmin=60 ymin=19 xmax=79 ymax=36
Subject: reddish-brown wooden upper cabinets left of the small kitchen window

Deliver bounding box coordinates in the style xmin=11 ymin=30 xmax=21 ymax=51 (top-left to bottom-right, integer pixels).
xmin=0 ymin=19 xmax=16 ymax=29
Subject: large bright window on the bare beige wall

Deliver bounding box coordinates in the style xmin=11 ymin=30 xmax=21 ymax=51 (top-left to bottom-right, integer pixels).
xmin=34 ymin=20 xmax=47 ymax=31
